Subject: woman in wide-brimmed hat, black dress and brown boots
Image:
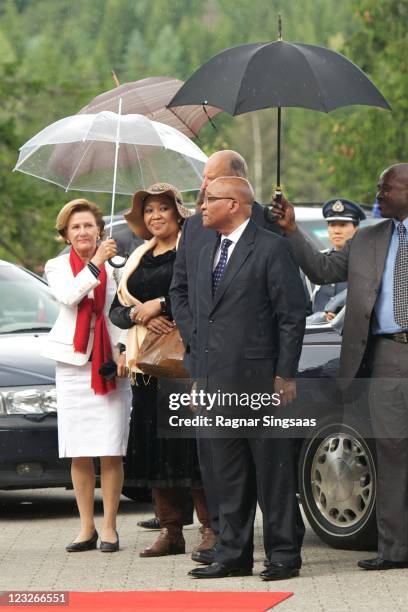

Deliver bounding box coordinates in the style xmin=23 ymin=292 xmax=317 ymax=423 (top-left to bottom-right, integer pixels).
xmin=110 ymin=183 xmax=215 ymax=557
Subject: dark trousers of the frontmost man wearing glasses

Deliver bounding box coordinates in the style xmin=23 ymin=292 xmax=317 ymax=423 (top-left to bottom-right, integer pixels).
xmin=211 ymin=438 xmax=304 ymax=568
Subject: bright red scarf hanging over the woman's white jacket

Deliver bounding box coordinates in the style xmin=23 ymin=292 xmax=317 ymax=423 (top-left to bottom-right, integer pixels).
xmin=69 ymin=247 xmax=116 ymax=395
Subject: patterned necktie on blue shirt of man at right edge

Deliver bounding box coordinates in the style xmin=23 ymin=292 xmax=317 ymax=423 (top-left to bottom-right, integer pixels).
xmin=393 ymin=221 xmax=408 ymax=330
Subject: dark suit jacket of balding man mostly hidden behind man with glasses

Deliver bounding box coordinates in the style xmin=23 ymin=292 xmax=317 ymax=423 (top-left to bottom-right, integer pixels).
xmin=170 ymin=202 xmax=282 ymax=360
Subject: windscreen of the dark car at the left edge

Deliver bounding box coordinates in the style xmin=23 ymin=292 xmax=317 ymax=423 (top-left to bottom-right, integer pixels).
xmin=0 ymin=266 xmax=59 ymax=334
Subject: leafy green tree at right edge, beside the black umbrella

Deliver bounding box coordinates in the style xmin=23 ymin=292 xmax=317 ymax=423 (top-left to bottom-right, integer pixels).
xmin=324 ymin=0 xmax=408 ymax=202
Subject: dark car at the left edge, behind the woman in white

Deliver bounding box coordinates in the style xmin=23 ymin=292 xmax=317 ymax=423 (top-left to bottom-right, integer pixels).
xmin=0 ymin=261 xmax=146 ymax=501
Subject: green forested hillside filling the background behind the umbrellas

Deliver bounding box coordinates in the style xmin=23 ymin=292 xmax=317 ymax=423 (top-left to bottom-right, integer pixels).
xmin=0 ymin=0 xmax=394 ymax=267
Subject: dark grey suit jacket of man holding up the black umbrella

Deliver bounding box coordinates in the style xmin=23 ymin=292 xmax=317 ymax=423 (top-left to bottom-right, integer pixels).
xmin=289 ymin=219 xmax=393 ymax=380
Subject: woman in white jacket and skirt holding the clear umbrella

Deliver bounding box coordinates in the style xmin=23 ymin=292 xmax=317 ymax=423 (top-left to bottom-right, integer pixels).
xmin=43 ymin=199 xmax=131 ymax=552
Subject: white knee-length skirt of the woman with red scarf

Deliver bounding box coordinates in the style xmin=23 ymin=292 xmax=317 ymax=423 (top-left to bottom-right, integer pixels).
xmin=55 ymin=362 xmax=132 ymax=458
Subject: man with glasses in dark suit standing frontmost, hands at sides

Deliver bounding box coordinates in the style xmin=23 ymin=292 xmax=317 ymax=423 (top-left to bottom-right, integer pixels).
xmin=190 ymin=177 xmax=305 ymax=580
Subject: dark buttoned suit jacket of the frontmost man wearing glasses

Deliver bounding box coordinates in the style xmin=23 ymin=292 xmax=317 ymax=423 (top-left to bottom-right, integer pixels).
xmin=191 ymin=221 xmax=305 ymax=384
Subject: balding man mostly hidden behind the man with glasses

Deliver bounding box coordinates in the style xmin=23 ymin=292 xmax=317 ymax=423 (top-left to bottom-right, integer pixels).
xmin=170 ymin=150 xmax=284 ymax=563
